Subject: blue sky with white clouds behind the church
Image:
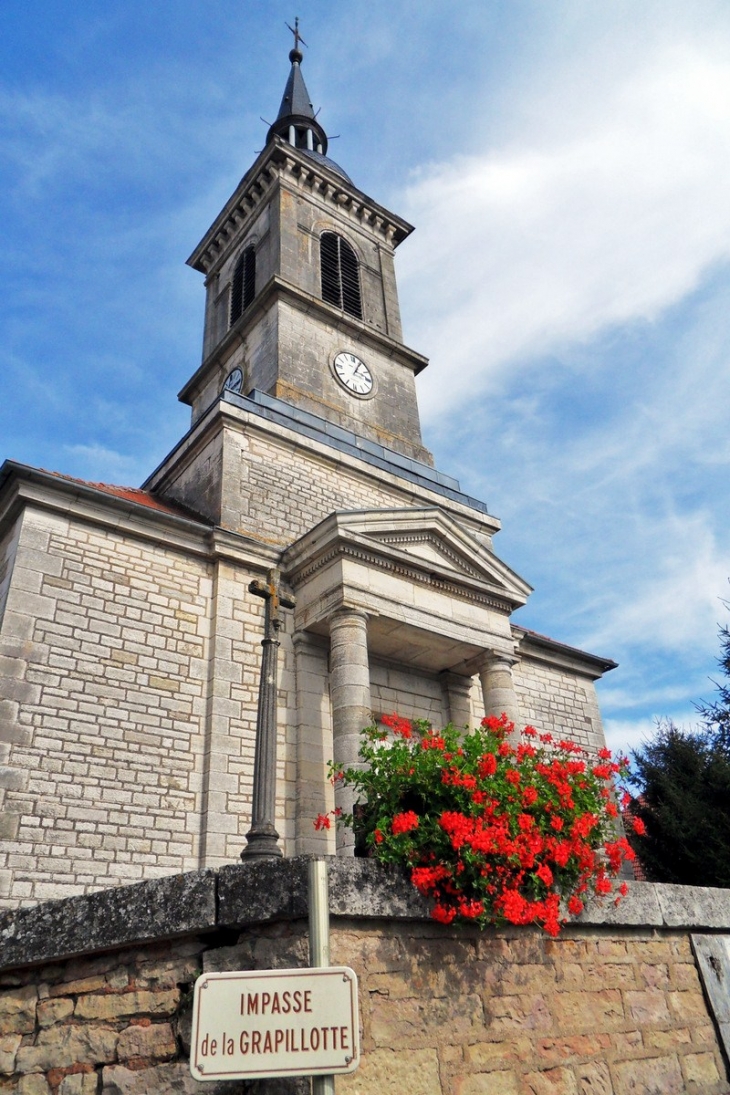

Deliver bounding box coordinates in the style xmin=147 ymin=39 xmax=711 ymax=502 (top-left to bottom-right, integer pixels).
xmin=0 ymin=0 xmax=730 ymax=748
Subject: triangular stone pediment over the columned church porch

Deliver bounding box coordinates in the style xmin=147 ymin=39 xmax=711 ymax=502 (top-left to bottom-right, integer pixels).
xmin=285 ymin=507 xmax=532 ymax=610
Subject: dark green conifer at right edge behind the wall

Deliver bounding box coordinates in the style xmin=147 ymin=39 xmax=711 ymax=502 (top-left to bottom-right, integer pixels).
xmin=629 ymin=714 xmax=730 ymax=887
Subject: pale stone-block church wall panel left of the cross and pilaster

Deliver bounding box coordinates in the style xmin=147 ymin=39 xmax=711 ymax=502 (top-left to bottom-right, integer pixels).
xmin=0 ymin=509 xmax=210 ymax=904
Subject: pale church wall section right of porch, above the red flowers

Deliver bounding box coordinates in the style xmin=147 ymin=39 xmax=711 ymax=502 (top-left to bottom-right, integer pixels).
xmin=513 ymin=658 xmax=605 ymax=750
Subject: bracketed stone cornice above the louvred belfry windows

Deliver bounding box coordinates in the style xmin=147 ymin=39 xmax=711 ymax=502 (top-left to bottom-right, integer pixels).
xmin=187 ymin=138 xmax=413 ymax=275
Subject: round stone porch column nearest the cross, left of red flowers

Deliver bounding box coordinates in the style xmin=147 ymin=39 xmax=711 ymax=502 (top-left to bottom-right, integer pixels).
xmin=329 ymin=609 xmax=372 ymax=855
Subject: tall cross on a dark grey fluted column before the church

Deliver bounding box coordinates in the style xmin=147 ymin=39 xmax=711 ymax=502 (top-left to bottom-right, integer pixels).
xmin=241 ymin=570 xmax=296 ymax=860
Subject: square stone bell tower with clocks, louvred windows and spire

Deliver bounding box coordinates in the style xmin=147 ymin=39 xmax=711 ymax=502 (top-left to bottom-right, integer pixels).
xmin=179 ymin=35 xmax=432 ymax=465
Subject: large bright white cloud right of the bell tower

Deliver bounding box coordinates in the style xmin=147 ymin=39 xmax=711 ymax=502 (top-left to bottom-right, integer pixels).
xmin=399 ymin=28 xmax=730 ymax=419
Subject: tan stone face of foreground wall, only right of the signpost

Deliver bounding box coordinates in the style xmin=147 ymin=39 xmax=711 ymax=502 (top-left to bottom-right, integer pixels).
xmin=333 ymin=924 xmax=730 ymax=1095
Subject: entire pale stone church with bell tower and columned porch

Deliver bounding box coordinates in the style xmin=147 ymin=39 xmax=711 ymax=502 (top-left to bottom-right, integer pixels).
xmin=0 ymin=48 xmax=614 ymax=908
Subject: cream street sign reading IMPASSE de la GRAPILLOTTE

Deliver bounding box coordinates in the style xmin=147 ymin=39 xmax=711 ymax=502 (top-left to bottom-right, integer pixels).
xmin=190 ymin=966 xmax=360 ymax=1081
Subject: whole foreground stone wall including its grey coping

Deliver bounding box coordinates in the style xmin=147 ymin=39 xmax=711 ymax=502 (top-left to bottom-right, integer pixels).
xmin=0 ymin=860 xmax=730 ymax=1095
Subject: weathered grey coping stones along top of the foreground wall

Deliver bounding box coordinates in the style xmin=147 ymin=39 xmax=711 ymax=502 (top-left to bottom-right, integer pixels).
xmin=0 ymin=855 xmax=730 ymax=970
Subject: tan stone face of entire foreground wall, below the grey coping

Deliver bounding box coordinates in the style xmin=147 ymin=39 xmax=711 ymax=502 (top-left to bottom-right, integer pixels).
xmin=0 ymin=920 xmax=730 ymax=1095
